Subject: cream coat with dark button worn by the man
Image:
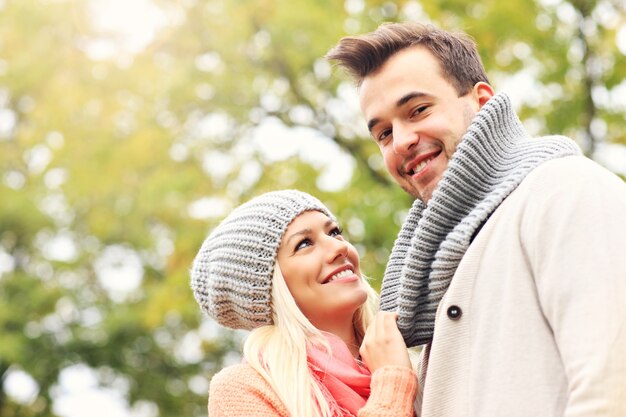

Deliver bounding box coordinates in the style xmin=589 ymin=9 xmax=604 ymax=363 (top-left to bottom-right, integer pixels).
xmin=420 ymin=156 xmax=626 ymax=417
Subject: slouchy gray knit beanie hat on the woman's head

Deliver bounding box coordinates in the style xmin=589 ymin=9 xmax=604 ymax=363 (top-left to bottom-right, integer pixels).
xmin=191 ymin=190 xmax=334 ymax=330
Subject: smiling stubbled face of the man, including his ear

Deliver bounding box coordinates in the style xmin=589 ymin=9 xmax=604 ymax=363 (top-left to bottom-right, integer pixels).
xmin=360 ymin=46 xmax=493 ymax=202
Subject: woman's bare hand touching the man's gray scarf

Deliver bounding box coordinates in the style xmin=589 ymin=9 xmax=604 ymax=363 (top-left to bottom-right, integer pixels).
xmin=359 ymin=311 xmax=411 ymax=373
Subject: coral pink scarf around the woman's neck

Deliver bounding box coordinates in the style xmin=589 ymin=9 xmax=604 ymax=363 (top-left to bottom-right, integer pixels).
xmin=307 ymin=332 xmax=372 ymax=416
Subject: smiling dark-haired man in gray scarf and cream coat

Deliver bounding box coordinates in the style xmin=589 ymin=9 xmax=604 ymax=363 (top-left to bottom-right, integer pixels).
xmin=327 ymin=23 xmax=626 ymax=417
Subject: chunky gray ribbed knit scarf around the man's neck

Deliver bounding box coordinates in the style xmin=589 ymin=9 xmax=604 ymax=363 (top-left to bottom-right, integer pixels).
xmin=380 ymin=94 xmax=580 ymax=347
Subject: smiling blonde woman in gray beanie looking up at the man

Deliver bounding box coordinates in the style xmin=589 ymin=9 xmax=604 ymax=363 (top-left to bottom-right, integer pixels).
xmin=191 ymin=190 xmax=417 ymax=417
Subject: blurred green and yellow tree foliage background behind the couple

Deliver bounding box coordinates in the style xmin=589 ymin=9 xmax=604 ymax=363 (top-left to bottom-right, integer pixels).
xmin=0 ymin=0 xmax=626 ymax=417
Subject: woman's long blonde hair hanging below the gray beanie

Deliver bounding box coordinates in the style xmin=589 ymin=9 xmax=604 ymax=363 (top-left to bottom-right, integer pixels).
xmin=243 ymin=263 xmax=378 ymax=417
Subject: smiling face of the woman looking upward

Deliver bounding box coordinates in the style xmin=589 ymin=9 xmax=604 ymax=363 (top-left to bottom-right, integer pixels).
xmin=277 ymin=211 xmax=367 ymax=330
